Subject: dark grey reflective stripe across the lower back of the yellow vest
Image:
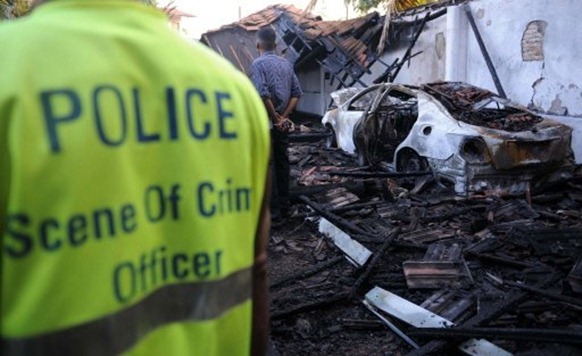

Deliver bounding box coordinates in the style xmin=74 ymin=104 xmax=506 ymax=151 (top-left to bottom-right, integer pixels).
xmin=0 ymin=269 xmax=252 ymax=356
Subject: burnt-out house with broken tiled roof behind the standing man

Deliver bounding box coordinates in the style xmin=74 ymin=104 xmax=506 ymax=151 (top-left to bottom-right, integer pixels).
xmin=201 ymin=5 xmax=383 ymax=115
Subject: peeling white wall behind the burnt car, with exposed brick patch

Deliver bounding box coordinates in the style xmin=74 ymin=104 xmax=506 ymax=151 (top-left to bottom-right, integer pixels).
xmin=363 ymin=0 xmax=582 ymax=116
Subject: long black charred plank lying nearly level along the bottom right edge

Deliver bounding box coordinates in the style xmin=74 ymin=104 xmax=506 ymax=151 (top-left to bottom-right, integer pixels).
xmin=408 ymin=327 xmax=582 ymax=344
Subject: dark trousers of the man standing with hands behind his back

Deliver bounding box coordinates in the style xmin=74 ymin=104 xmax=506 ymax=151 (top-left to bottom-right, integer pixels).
xmin=271 ymin=128 xmax=290 ymax=219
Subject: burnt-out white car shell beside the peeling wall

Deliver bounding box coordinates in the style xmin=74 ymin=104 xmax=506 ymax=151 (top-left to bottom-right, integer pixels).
xmin=322 ymin=82 xmax=574 ymax=194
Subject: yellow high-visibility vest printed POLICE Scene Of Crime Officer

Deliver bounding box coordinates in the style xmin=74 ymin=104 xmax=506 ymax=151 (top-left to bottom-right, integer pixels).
xmin=0 ymin=0 xmax=269 ymax=355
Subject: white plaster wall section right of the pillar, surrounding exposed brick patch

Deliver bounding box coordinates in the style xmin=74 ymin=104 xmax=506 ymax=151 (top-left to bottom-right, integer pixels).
xmin=466 ymin=0 xmax=582 ymax=116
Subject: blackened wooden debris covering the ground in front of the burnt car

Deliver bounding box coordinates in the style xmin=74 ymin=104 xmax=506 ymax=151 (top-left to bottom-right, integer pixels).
xmin=270 ymin=120 xmax=582 ymax=355
